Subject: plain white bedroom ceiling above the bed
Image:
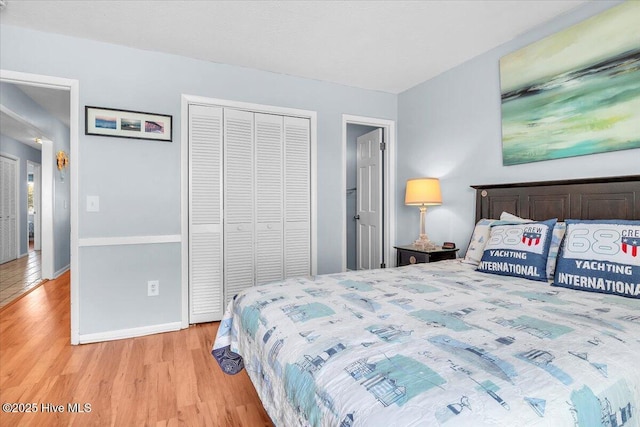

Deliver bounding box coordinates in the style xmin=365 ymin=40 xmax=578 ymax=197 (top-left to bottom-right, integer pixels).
xmin=0 ymin=0 xmax=587 ymax=93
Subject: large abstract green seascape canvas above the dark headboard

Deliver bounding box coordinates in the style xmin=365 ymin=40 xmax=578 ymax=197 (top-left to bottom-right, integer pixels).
xmin=500 ymin=1 xmax=640 ymax=166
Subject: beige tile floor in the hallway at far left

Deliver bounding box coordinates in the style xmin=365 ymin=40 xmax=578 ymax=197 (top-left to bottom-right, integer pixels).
xmin=0 ymin=250 xmax=42 ymax=307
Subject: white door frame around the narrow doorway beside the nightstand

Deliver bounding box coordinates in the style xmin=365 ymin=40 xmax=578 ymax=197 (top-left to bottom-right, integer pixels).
xmin=341 ymin=114 xmax=396 ymax=271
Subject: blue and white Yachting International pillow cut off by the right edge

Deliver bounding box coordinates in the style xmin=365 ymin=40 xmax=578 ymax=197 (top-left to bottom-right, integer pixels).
xmin=553 ymin=220 xmax=640 ymax=299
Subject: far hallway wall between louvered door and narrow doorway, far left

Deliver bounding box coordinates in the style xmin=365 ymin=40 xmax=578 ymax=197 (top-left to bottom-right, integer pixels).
xmin=0 ymin=134 xmax=40 ymax=257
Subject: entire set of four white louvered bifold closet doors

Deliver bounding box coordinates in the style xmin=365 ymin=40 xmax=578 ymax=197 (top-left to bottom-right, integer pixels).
xmin=189 ymin=105 xmax=311 ymax=323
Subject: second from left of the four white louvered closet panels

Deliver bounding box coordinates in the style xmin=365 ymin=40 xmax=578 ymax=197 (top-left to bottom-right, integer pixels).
xmin=224 ymin=109 xmax=255 ymax=304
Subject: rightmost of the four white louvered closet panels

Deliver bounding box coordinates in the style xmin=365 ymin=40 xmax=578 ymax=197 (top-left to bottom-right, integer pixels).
xmin=284 ymin=117 xmax=311 ymax=277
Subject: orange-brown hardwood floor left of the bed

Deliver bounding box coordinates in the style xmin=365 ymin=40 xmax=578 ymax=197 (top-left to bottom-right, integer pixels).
xmin=0 ymin=273 xmax=272 ymax=427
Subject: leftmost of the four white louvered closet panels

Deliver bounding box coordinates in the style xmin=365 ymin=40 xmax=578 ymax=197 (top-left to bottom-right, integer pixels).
xmin=189 ymin=105 xmax=225 ymax=323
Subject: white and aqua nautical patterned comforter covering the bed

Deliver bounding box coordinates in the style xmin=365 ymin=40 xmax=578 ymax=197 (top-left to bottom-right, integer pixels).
xmin=212 ymin=260 xmax=640 ymax=427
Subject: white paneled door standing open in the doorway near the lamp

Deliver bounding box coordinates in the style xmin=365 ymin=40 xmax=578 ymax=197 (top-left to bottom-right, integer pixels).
xmin=356 ymin=129 xmax=382 ymax=270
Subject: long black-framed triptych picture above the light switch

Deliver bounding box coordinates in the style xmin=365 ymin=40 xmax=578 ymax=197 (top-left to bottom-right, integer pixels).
xmin=84 ymin=105 xmax=173 ymax=141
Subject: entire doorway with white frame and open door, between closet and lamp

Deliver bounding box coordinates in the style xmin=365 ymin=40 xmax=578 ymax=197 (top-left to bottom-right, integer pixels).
xmin=342 ymin=115 xmax=395 ymax=271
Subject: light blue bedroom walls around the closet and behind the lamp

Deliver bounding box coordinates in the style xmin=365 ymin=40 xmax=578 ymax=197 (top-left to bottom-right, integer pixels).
xmin=0 ymin=2 xmax=640 ymax=334
